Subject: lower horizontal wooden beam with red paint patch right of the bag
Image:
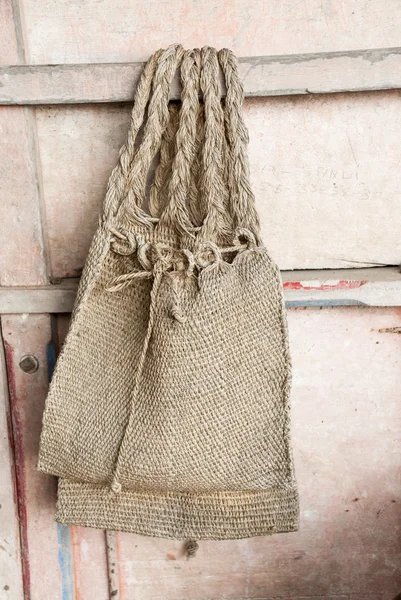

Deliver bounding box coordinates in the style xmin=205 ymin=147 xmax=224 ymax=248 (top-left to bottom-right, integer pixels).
xmin=0 ymin=267 xmax=401 ymax=314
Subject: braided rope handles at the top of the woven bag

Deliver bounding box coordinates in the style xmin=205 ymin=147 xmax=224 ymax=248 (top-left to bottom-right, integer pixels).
xmin=105 ymin=44 xmax=259 ymax=246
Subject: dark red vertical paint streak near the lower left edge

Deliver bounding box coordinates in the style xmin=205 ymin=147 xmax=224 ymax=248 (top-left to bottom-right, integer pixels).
xmin=4 ymin=340 xmax=31 ymax=600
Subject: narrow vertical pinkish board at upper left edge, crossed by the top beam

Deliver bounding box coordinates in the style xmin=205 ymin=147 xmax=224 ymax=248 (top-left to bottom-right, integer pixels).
xmin=0 ymin=0 xmax=47 ymax=285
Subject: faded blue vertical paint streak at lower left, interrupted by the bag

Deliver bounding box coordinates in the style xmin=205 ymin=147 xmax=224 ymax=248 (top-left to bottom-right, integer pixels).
xmin=46 ymin=341 xmax=75 ymax=600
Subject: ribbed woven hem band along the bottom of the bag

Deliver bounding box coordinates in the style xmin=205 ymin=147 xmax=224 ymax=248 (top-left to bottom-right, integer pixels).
xmin=56 ymin=479 xmax=299 ymax=540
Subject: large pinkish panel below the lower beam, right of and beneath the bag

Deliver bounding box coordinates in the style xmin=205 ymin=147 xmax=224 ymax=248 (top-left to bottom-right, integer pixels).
xmin=118 ymin=308 xmax=401 ymax=600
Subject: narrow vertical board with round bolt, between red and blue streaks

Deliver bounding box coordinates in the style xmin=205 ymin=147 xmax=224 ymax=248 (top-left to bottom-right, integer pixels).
xmin=2 ymin=315 xmax=61 ymax=600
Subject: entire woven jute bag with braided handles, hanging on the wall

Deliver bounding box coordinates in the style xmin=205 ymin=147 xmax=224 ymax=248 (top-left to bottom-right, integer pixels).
xmin=38 ymin=45 xmax=298 ymax=539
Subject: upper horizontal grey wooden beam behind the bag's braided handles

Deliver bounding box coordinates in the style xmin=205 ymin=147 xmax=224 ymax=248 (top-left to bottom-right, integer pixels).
xmin=0 ymin=48 xmax=401 ymax=105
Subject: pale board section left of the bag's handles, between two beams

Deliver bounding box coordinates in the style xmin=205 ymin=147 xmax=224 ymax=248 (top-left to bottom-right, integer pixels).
xmin=36 ymin=106 xmax=130 ymax=277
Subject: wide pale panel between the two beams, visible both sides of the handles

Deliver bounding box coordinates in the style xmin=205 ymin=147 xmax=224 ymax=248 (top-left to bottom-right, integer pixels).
xmin=37 ymin=92 xmax=401 ymax=277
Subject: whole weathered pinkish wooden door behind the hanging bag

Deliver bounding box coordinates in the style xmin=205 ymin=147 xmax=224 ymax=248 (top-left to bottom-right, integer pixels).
xmin=0 ymin=0 xmax=401 ymax=600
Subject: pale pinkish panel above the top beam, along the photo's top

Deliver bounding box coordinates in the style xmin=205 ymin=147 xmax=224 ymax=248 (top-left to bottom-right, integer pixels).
xmin=21 ymin=0 xmax=401 ymax=64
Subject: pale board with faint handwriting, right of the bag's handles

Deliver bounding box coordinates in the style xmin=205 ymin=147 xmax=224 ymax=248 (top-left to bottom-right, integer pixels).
xmin=245 ymin=92 xmax=401 ymax=270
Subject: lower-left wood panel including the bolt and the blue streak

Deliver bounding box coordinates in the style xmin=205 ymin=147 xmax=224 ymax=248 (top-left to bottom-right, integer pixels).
xmin=2 ymin=315 xmax=108 ymax=600
